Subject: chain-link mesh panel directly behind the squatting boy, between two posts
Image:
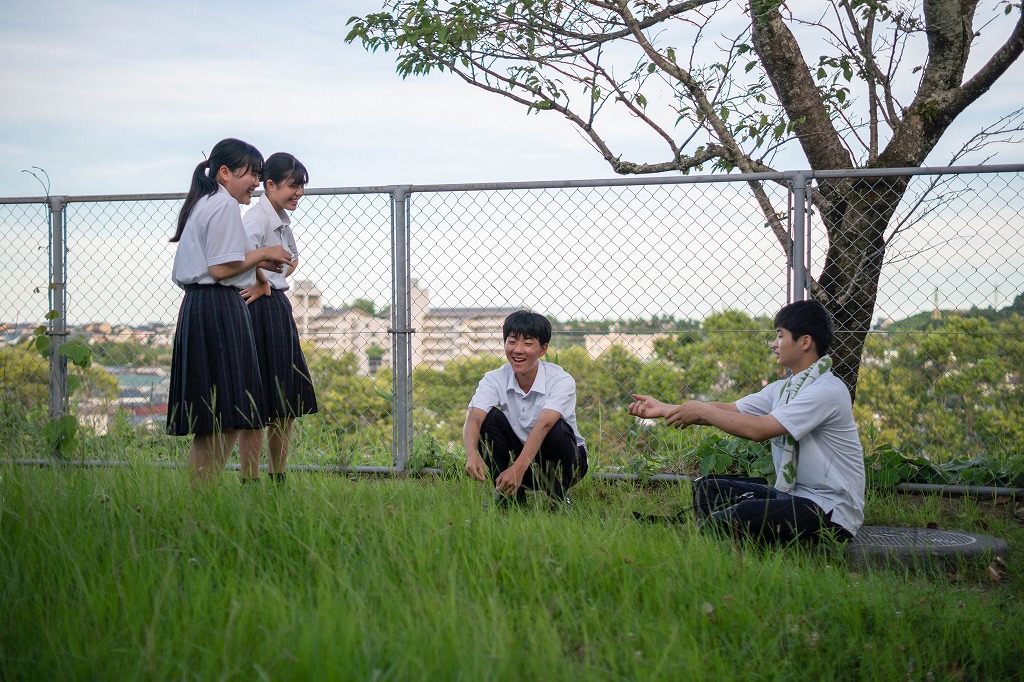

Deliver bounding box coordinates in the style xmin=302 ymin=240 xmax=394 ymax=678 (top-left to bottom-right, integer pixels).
xmin=411 ymin=182 xmax=786 ymax=470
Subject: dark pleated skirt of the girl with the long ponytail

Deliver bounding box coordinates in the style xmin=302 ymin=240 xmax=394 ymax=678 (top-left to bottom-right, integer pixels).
xmin=167 ymin=285 xmax=266 ymax=435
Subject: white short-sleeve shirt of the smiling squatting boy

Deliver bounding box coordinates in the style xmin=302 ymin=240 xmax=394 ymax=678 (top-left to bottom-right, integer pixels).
xmin=469 ymin=360 xmax=584 ymax=446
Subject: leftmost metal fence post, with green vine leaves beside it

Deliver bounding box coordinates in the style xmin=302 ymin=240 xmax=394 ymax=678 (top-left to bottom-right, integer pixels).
xmin=47 ymin=197 xmax=68 ymax=438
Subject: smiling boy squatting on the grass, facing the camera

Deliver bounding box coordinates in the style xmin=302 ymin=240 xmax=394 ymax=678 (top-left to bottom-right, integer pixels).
xmin=463 ymin=310 xmax=588 ymax=507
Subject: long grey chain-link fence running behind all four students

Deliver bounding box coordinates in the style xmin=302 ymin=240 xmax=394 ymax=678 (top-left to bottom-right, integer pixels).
xmin=0 ymin=167 xmax=1024 ymax=471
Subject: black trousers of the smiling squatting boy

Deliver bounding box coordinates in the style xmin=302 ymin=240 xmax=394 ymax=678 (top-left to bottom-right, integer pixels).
xmin=480 ymin=408 xmax=588 ymax=500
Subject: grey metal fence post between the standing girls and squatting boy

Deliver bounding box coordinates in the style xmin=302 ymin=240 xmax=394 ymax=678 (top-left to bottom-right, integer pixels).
xmin=391 ymin=186 xmax=415 ymax=472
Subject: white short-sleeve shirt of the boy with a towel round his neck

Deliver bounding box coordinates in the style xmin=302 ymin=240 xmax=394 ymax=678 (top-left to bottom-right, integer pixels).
xmin=736 ymin=372 xmax=864 ymax=534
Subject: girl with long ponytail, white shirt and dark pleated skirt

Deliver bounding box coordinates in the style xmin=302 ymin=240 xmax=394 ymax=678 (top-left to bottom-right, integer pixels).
xmin=167 ymin=138 xmax=292 ymax=481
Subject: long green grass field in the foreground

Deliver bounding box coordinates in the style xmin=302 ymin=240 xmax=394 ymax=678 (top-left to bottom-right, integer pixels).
xmin=0 ymin=465 xmax=1024 ymax=681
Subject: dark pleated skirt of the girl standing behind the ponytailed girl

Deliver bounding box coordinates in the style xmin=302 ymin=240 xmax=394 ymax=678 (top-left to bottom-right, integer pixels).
xmin=248 ymin=289 xmax=316 ymax=419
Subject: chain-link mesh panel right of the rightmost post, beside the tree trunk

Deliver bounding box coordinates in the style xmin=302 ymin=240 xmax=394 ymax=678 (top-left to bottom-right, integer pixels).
xmin=811 ymin=173 xmax=1024 ymax=461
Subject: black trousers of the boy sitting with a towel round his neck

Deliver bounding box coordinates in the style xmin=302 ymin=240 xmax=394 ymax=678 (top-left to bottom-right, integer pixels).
xmin=693 ymin=476 xmax=853 ymax=544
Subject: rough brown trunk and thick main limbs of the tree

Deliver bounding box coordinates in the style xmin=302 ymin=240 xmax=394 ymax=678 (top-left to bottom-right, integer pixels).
xmin=750 ymin=0 xmax=1024 ymax=397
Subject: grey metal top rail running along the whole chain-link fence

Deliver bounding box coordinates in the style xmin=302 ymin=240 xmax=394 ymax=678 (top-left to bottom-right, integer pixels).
xmin=0 ymin=164 xmax=1024 ymax=205
